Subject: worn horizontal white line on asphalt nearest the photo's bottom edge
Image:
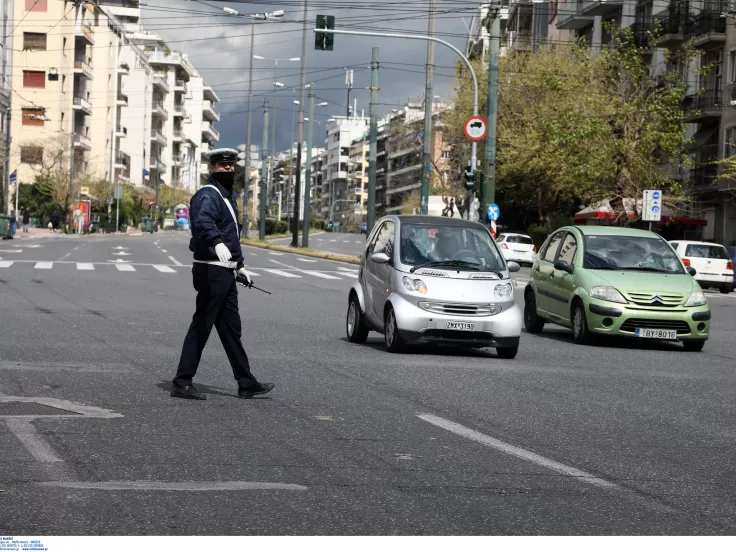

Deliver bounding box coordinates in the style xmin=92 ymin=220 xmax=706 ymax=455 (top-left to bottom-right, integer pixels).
xmin=38 ymin=481 xmax=307 ymax=492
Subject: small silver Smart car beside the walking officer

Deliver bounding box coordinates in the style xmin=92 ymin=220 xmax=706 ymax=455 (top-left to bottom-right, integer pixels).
xmin=346 ymin=215 xmax=522 ymax=358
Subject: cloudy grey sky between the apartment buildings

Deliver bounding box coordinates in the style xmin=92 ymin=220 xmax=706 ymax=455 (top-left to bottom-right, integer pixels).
xmin=141 ymin=0 xmax=479 ymax=155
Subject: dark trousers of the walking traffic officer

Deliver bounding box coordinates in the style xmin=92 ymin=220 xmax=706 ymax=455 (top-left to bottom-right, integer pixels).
xmin=174 ymin=263 xmax=258 ymax=387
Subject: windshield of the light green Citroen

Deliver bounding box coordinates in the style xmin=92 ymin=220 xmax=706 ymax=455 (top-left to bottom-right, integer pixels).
xmin=583 ymin=236 xmax=684 ymax=274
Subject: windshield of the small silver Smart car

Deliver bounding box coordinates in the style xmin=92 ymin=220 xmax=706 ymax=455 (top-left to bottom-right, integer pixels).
xmin=401 ymin=223 xmax=505 ymax=270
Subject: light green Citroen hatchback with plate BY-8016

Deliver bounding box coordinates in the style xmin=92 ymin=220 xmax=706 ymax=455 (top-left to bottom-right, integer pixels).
xmin=524 ymin=226 xmax=710 ymax=351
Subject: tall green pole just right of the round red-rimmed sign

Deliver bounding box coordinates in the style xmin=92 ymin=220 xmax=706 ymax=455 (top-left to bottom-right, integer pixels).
xmin=481 ymin=8 xmax=501 ymax=225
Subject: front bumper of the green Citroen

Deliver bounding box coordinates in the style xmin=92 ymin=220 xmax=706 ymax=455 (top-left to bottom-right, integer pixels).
xmin=586 ymin=299 xmax=710 ymax=340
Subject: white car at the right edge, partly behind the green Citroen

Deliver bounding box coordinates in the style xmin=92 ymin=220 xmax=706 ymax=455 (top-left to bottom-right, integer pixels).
xmin=670 ymin=240 xmax=733 ymax=293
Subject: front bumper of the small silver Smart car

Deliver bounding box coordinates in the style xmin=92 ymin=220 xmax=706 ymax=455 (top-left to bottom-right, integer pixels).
xmin=390 ymin=295 xmax=522 ymax=347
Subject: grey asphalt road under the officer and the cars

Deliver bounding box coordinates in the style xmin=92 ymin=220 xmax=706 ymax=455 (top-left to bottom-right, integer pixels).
xmin=0 ymin=234 xmax=736 ymax=535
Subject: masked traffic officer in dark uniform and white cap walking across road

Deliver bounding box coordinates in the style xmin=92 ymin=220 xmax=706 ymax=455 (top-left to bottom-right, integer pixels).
xmin=171 ymin=148 xmax=274 ymax=400
